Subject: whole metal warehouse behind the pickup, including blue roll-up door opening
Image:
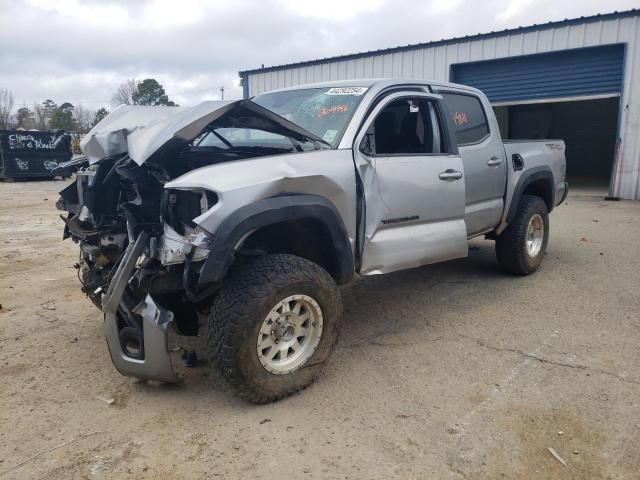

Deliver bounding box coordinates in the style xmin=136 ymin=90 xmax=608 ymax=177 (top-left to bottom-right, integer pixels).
xmin=240 ymin=10 xmax=640 ymax=200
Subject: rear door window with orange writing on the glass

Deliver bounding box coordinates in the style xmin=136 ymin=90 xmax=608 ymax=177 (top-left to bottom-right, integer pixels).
xmin=442 ymin=92 xmax=489 ymax=146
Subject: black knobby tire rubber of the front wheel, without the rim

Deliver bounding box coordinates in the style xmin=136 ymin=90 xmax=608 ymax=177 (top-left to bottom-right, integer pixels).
xmin=208 ymin=254 xmax=342 ymax=403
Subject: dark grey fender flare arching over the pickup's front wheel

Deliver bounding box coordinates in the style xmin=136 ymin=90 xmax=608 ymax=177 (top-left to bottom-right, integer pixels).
xmin=198 ymin=194 xmax=354 ymax=285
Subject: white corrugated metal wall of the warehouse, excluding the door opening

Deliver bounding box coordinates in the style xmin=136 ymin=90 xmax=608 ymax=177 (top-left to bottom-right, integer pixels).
xmin=245 ymin=12 xmax=640 ymax=199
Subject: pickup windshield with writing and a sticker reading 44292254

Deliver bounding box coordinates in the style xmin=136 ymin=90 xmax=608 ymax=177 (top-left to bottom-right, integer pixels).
xmin=252 ymin=87 xmax=367 ymax=147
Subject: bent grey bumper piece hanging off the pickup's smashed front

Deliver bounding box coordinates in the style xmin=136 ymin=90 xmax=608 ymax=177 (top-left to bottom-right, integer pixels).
xmin=102 ymin=233 xmax=180 ymax=383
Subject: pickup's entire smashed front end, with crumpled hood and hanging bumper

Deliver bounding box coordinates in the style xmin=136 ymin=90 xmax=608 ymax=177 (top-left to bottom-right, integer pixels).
xmin=57 ymin=100 xmax=324 ymax=383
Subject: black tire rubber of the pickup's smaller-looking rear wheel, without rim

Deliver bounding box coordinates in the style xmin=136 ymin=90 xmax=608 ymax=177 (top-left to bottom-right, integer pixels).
xmin=496 ymin=195 xmax=549 ymax=275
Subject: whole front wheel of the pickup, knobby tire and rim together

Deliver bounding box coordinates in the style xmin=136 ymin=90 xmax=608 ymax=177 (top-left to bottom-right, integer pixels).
xmin=208 ymin=254 xmax=342 ymax=403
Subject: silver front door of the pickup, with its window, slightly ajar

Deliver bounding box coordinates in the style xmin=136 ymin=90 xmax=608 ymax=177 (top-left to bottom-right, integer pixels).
xmin=354 ymin=92 xmax=467 ymax=275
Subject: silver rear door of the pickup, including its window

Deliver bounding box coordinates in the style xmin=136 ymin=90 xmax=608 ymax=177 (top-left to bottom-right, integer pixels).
xmin=439 ymin=90 xmax=507 ymax=236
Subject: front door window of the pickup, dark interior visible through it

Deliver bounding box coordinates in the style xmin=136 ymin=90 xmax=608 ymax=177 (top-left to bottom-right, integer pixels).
xmin=361 ymin=98 xmax=442 ymax=156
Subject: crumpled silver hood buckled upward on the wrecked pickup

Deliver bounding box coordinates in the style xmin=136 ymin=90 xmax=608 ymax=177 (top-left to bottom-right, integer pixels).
xmin=80 ymin=100 xmax=326 ymax=165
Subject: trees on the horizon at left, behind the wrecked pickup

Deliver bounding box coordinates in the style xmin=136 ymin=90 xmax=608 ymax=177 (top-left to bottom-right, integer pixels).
xmin=0 ymin=78 xmax=178 ymax=133
